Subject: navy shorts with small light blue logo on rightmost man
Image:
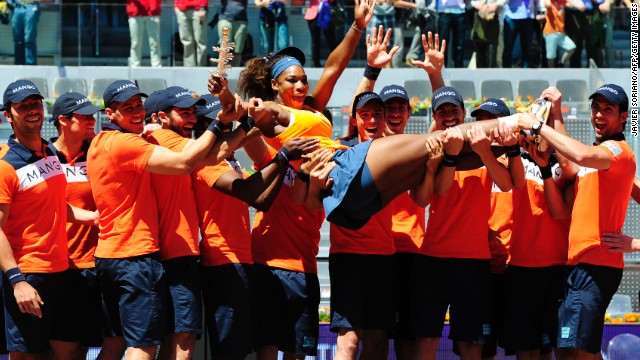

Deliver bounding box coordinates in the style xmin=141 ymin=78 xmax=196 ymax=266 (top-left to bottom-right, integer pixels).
xmin=558 ymin=263 xmax=622 ymax=354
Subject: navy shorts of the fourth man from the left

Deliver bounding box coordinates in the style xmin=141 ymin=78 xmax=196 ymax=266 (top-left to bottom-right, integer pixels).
xmin=162 ymin=256 xmax=202 ymax=334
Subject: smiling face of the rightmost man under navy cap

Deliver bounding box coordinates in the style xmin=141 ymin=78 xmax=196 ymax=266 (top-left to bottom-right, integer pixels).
xmin=591 ymin=95 xmax=629 ymax=142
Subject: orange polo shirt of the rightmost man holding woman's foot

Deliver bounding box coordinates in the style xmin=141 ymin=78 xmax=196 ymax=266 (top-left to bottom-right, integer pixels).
xmin=569 ymin=140 xmax=636 ymax=268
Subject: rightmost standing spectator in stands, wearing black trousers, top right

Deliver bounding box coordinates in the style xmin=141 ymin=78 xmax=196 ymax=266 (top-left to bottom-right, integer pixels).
xmin=565 ymin=0 xmax=609 ymax=68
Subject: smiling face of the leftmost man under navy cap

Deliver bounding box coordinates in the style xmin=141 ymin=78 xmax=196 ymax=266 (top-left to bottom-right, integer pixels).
xmin=4 ymin=95 xmax=44 ymax=136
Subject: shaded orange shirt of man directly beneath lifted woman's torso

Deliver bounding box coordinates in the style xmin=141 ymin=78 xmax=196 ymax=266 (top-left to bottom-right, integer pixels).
xmin=251 ymin=148 xmax=324 ymax=274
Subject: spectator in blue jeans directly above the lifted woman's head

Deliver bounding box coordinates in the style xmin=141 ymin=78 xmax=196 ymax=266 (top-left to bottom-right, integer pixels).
xmin=255 ymin=0 xmax=289 ymax=55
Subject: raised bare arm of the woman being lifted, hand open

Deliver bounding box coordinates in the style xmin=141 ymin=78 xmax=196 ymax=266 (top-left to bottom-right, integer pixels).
xmin=306 ymin=0 xmax=376 ymax=111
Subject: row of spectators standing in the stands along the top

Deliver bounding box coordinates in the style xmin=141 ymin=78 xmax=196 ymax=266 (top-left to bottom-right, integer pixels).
xmin=7 ymin=0 xmax=637 ymax=68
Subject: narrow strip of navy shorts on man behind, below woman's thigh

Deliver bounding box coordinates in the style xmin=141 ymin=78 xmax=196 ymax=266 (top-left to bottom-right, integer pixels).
xmin=393 ymin=253 xmax=424 ymax=341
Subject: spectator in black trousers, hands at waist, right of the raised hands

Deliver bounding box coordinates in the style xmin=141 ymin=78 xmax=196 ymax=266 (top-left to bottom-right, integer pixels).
xmin=471 ymin=0 xmax=505 ymax=68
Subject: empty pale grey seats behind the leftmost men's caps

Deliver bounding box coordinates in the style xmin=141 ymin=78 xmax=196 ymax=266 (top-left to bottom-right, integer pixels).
xmin=16 ymin=77 xmax=167 ymax=99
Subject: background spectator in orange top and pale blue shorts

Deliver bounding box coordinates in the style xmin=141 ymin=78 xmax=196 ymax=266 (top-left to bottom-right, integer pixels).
xmin=542 ymin=0 xmax=576 ymax=68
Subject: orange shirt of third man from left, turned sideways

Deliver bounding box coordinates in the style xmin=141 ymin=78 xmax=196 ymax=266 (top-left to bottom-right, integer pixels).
xmin=87 ymin=130 xmax=160 ymax=259
